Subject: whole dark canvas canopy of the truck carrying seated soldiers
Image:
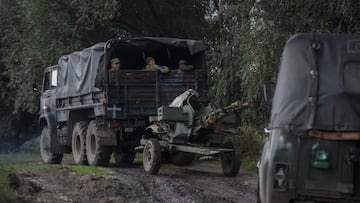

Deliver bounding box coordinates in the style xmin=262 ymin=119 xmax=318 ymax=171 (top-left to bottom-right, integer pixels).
xmin=56 ymin=37 xmax=206 ymax=98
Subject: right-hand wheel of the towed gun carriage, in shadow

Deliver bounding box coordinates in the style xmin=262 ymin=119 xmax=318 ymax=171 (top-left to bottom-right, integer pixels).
xmin=221 ymin=137 xmax=241 ymax=177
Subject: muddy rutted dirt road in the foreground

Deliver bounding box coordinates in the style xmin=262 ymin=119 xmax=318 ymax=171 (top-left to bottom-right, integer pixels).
xmin=8 ymin=156 xmax=257 ymax=203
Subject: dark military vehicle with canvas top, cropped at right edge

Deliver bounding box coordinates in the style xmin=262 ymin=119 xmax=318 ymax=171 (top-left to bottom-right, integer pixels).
xmin=258 ymin=33 xmax=360 ymax=203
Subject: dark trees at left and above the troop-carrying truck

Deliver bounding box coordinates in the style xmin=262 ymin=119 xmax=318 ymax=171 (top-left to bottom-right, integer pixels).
xmin=0 ymin=0 xmax=214 ymax=151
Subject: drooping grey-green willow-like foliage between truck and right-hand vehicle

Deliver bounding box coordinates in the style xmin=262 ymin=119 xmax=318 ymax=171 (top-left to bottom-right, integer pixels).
xmin=210 ymin=0 xmax=360 ymax=126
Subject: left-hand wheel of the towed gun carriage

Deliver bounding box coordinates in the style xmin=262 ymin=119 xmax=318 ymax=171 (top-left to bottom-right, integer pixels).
xmin=143 ymin=138 xmax=161 ymax=175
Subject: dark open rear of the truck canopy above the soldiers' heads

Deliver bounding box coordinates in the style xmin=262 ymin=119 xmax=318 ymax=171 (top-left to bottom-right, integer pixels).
xmin=105 ymin=37 xmax=205 ymax=70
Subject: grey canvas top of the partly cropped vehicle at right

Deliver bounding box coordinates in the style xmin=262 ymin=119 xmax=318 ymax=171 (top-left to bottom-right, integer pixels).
xmin=270 ymin=34 xmax=360 ymax=131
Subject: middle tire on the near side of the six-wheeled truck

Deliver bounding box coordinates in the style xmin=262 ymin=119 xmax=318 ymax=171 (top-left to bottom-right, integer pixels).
xmin=71 ymin=121 xmax=88 ymax=165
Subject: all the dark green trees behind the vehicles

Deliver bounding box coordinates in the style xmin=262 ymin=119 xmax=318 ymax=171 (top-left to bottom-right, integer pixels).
xmin=0 ymin=0 xmax=360 ymax=157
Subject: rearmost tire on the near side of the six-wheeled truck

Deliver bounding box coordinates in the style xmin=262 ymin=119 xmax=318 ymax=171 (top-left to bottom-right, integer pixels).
xmin=86 ymin=121 xmax=113 ymax=166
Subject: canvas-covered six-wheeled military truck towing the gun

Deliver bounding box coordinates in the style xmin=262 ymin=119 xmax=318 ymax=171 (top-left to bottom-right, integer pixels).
xmin=39 ymin=37 xmax=208 ymax=166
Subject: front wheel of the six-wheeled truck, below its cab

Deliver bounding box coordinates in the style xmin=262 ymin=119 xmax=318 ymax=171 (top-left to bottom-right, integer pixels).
xmin=40 ymin=127 xmax=63 ymax=164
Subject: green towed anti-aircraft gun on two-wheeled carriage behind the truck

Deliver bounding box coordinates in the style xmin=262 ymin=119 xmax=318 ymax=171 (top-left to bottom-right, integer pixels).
xmin=137 ymin=89 xmax=248 ymax=177
